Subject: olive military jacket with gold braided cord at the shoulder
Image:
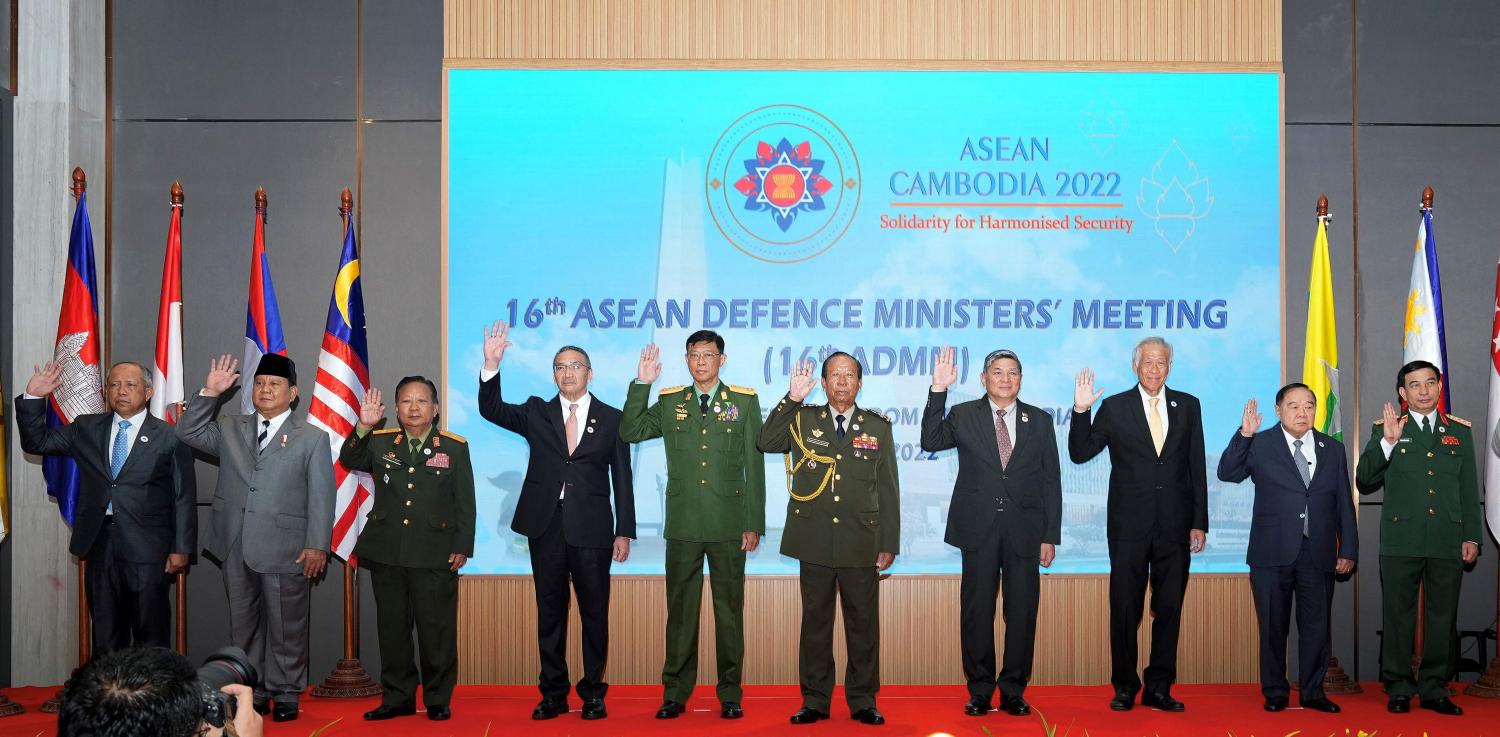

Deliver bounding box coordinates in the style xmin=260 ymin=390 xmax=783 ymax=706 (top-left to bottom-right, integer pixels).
xmin=759 ymin=396 xmax=902 ymax=567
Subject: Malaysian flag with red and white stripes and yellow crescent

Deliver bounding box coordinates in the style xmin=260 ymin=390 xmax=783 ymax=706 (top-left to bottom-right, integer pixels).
xmin=308 ymin=196 xmax=375 ymax=560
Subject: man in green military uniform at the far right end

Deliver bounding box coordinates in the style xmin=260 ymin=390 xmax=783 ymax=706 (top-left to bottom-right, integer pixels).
xmin=1355 ymin=360 xmax=1482 ymax=716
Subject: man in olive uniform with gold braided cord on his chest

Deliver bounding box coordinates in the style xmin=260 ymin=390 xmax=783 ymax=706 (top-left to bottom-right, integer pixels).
xmin=759 ymin=351 xmax=902 ymax=725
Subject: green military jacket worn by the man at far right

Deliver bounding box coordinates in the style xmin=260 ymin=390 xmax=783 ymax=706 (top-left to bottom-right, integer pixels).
xmin=1355 ymin=414 xmax=1484 ymax=560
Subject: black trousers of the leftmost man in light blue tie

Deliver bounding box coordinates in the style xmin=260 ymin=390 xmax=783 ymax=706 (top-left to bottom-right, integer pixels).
xmin=84 ymin=518 xmax=173 ymax=657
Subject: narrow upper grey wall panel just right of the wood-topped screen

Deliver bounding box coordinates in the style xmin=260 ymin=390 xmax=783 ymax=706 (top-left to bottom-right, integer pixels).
xmin=1281 ymin=0 xmax=1353 ymax=123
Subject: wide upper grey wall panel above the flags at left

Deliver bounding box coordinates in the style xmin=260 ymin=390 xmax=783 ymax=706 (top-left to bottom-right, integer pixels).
xmin=113 ymin=0 xmax=357 ymax=120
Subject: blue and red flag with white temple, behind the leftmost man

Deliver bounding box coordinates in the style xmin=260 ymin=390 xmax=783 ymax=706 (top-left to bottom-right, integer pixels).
xmin=42 ymin=188 xmax=104 ymax=525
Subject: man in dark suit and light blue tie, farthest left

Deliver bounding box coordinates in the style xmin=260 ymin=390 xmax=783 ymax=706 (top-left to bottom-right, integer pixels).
xmin=15 ymin=362 xmax=198 ymax=657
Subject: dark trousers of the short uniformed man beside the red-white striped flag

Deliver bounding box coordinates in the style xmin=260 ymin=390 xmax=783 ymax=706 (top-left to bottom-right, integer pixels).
xmin=360 ymin=560 xmax=459 ymax=708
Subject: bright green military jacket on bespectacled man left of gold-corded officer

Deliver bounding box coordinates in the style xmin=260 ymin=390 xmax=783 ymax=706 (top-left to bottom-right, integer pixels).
xmin=620 ymin=381 xmax=765 ymax=542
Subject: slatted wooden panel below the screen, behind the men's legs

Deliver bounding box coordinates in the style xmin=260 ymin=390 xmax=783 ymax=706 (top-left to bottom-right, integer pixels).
xmin=459 ymin=575 xmax=1260 ymax=684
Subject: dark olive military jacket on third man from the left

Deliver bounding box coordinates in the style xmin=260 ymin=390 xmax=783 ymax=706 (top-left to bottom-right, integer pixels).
xmin=339 ymin=428 xmax=474 ymax=569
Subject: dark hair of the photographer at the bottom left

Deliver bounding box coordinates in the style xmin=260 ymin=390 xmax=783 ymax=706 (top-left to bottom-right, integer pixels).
xmin=57 ymin=647 xmax=203 ymax=737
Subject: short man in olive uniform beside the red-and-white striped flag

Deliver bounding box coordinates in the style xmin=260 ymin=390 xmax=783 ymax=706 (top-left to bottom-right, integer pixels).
xmin=339 ymin=377 xmax=474 ymax=720
